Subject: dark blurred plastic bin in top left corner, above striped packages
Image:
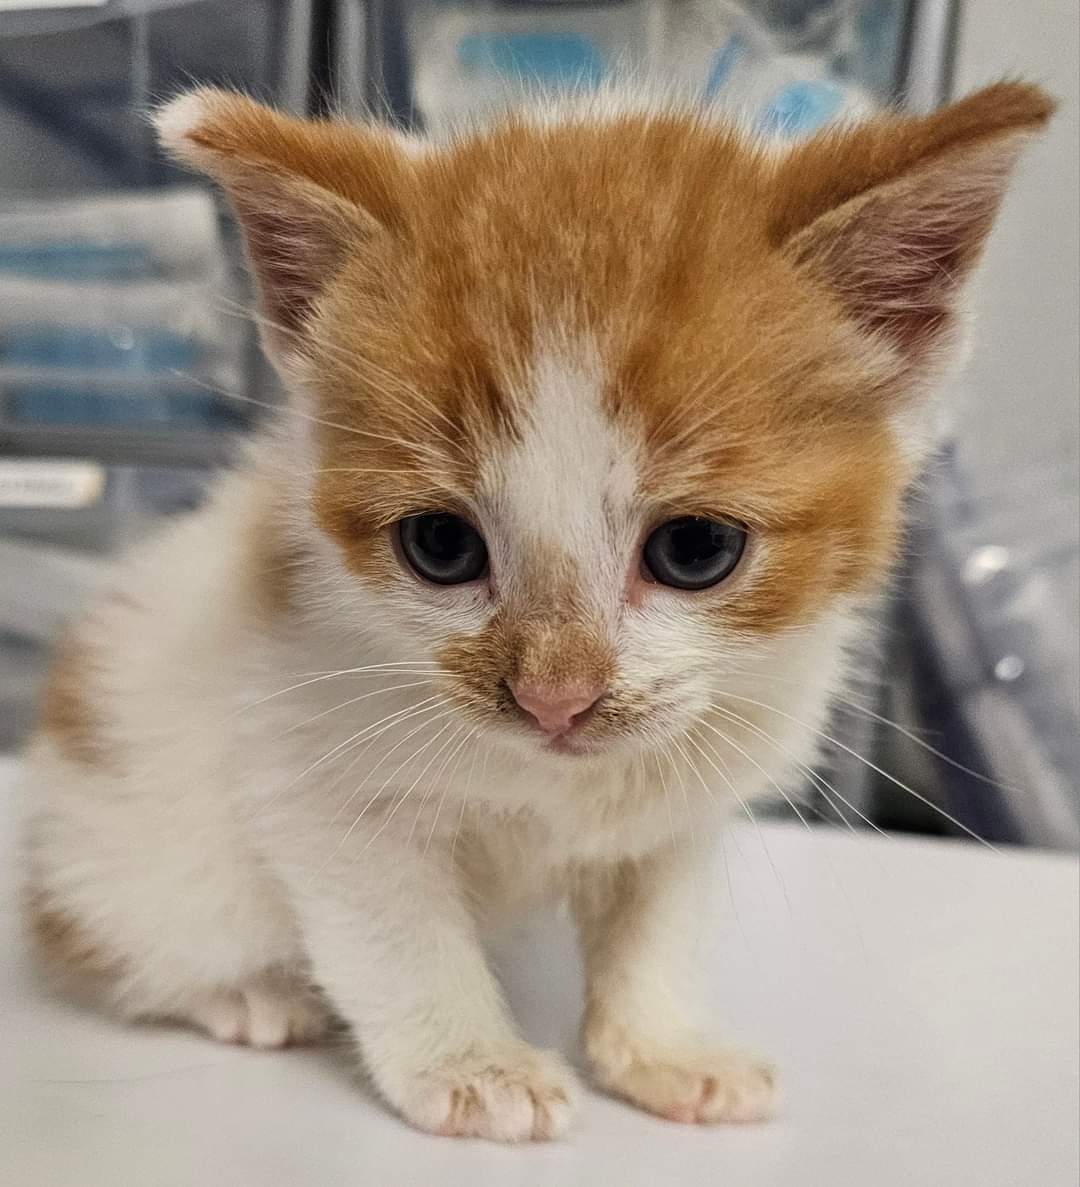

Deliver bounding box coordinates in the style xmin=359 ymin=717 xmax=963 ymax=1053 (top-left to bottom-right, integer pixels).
xmin=0 ymin=0 xmax=312 ymax=197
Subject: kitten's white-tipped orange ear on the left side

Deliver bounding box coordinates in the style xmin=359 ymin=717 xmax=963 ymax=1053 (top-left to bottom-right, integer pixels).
xmin=154 ymin=88 xmax=408 ymax=361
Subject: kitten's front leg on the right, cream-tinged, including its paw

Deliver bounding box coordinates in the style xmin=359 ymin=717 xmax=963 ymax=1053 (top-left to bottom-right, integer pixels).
xmin=574 ymin=855 xmax=775 ymax=1122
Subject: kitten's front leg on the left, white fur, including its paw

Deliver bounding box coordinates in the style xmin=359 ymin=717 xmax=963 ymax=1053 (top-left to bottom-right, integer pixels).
xmin=286 ymin=826 xmax=576 ymax=1142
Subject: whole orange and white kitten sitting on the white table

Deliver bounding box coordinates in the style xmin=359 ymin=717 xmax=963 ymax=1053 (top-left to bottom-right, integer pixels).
xmin=23 ymin=83 xmax=1052 ymax=1141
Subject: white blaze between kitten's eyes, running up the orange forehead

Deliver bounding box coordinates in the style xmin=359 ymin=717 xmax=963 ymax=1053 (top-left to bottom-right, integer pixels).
xmin=482 ymin=334 xmax=639 ymax=612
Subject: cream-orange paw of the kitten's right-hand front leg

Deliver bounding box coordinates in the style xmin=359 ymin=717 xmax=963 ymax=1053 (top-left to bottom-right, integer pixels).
xmin=585 ymin=1023 xmax=777 ymax=1124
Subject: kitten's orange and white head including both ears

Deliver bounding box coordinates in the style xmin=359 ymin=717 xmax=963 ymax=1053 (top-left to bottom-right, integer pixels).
xmin=158 ymin=84 xmax=1052 ymax=754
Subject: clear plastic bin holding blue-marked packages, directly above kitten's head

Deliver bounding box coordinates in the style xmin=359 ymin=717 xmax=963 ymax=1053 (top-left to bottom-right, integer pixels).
xmin=336 ymin=0 xmax=915 ymax=134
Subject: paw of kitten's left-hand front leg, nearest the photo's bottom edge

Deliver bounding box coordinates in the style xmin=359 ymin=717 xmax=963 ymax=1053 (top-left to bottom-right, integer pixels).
xmin=399 ymin=1043 xmax=577 ymax=1142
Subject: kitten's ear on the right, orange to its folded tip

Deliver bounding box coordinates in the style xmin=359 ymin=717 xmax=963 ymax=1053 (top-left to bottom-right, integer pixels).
xmin=769 ymin=83 xmax=1055 ymax=383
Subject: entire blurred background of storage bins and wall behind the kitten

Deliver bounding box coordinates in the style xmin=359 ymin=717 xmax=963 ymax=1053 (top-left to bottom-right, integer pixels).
xmin=0 ymin=0 xmax=1080 ymax=849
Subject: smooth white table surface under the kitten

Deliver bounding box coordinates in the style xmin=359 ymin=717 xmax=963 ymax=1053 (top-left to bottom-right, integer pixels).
xmin=0 ymin=766 xmax=1080 ymax=1187
